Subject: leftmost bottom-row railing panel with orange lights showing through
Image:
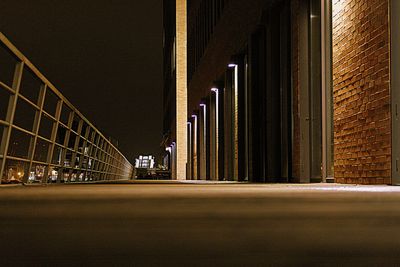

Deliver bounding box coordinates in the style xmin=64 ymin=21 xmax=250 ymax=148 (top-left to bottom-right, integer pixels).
xmin=1 ymin=159 xmax=29 ymax=184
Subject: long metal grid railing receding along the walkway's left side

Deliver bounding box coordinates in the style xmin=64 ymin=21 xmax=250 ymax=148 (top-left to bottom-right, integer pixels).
xmin=0 ymin=33 xmax=133 ymax=183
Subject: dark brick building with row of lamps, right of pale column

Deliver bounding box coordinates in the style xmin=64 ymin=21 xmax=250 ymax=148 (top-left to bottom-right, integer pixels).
xmin=164 ymin=0 xmax=400 ymax=184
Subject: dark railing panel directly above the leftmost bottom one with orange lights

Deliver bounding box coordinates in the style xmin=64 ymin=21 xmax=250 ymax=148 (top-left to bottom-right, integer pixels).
xmin=7 ymin=129 xmax=33 ymax=159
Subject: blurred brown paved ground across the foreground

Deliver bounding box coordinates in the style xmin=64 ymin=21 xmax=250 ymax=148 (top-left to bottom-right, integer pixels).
xmin=0 ymin=183 xmax=400 ymax=266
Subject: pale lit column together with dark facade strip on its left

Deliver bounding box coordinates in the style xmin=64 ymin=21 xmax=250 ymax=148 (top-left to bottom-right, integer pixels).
xmin=162 ymin=0 xmax=187 ymax=180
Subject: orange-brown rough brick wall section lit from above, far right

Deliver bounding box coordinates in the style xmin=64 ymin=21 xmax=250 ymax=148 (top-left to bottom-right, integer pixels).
xmin=332 ymin=0 xmax=391 ymax=184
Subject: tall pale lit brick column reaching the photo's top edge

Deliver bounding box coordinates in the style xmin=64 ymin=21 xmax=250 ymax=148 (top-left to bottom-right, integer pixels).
xmin=174 ymin=0 xmax=187 ymax=180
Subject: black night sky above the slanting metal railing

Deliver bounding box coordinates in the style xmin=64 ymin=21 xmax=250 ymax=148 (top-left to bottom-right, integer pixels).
xmin=0 ymin=0 xmax=162 ymax=162
